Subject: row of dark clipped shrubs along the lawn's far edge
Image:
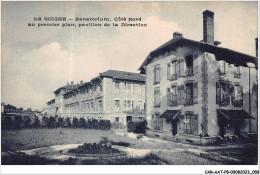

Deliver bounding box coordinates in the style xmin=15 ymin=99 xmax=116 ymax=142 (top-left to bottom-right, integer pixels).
xmin=2 ymin=116 xmax=111 ymax=130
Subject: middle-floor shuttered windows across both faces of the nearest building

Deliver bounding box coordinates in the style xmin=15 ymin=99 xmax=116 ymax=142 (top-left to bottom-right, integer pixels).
xmin=154 ymin=81 xmax=243 ymax=107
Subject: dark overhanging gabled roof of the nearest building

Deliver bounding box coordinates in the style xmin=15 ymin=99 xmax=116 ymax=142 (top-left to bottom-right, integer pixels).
xmin=138 ymin=37 xmax=257 ymax=71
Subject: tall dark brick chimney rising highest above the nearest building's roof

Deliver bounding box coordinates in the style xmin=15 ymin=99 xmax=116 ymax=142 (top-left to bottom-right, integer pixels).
xmin=202 ymin=10 xmax=214 ymax=44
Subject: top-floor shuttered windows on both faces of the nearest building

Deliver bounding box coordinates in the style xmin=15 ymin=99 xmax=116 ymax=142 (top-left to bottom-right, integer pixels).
xmin=154 ymin=55 xmax=241 ymax=83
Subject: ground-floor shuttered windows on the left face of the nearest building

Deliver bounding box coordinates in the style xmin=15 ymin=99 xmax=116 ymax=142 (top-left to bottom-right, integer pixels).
xmin=152 ymin=112 xmax=198 ymax=135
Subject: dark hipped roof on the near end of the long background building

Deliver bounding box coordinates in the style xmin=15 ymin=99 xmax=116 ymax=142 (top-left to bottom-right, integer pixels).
xmin=100 ymin=70 xmax=145 ymax=82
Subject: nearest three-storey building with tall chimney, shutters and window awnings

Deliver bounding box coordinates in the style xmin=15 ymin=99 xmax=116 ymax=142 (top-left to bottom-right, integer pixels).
xmin=139 ymin=10 xmax=257 ymax=144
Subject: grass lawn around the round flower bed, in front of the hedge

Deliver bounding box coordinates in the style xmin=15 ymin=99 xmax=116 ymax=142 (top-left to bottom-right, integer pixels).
xmin=1 ymin=128 xmax=221 ymax=165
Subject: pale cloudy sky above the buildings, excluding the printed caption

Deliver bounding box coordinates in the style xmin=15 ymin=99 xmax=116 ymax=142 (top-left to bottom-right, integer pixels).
xmin=1 ymin=1 xmax=258 ymax=110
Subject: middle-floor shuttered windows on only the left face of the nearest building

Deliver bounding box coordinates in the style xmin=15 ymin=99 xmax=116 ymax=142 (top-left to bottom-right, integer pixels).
xmin=154 ymin=82 xmax=198 ymax=107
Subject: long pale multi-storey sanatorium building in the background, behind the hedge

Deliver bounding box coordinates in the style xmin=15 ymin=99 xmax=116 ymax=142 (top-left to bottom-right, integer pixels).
xmin=47 ymin=70 xmax=145 ymax=125
